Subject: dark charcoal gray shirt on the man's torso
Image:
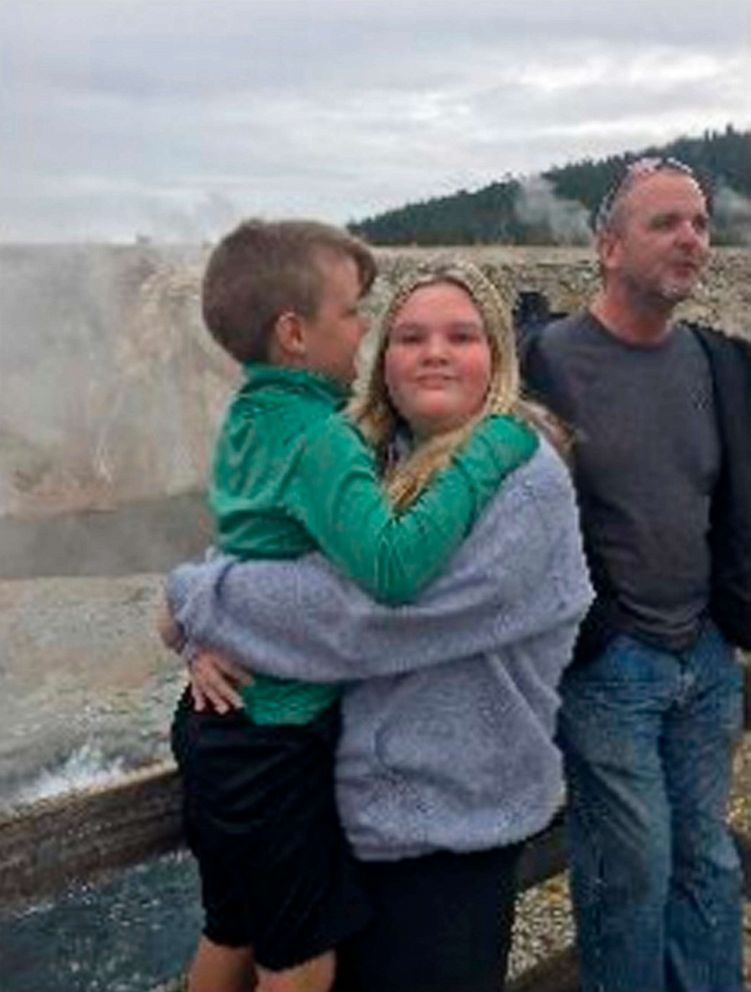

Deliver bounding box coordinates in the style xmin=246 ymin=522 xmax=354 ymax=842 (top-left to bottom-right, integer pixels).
xmin=531 ymin=313 xmax=720 ymax=650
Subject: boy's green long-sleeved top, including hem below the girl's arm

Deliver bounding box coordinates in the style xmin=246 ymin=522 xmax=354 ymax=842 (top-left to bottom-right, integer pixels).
xmin=210 ymin=363 xmax=538 ymax=723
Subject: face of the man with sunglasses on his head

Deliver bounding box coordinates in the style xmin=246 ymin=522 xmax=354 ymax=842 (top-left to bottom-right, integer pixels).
xmin=599 ymin=169 xmax=709 ymax=305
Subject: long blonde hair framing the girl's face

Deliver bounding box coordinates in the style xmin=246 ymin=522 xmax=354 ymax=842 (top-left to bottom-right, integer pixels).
xmin=347 ymin=259 xmax=552 ymax=509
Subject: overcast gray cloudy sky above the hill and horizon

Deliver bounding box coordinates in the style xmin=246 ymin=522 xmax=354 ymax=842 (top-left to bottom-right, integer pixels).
xmin=0 ymin=0 xmax=751 ymax=241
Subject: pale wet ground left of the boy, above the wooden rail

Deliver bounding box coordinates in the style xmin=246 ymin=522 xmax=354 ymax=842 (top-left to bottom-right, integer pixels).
xmin=0 ymin=575 xmax=184 ymax=806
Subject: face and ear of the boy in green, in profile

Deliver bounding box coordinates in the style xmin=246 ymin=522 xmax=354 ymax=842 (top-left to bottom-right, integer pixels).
xmin=302 ymin=254 xmax=367 ymax=385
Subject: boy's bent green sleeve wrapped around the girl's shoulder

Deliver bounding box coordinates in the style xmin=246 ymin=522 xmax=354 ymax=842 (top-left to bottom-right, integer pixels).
xmin=285 ymin=416 xmax=538 ymax=606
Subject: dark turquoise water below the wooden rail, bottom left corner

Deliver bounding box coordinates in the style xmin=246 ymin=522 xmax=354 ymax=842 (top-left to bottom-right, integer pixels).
xmin=0 ymin=852 xmax=201 ymax=992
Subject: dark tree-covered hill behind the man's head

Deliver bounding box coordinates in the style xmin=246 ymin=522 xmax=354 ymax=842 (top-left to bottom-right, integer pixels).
xmin=349 ymin=125 xmax=751 ymax=245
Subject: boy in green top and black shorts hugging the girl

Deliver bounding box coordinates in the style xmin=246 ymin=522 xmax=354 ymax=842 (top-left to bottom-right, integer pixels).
xmin=167 ymin=221 xmax=537 ymax=992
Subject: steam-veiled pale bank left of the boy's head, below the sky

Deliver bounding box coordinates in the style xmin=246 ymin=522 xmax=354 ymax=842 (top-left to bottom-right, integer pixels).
xmin=0 ymin=246 xmax=233 ymax=516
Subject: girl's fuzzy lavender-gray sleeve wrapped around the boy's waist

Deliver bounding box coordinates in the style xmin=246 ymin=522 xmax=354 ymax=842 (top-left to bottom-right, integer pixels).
xmin=167 ymin=446 xmax=592 ymax=682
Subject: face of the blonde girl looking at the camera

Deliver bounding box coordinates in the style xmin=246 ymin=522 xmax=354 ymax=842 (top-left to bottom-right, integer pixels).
xmin=384 ymin=282 xmax=492 ymax=437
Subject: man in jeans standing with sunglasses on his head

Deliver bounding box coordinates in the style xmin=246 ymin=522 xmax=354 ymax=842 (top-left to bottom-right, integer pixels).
xmin=525 ymin=159 xmax=751 ymax=992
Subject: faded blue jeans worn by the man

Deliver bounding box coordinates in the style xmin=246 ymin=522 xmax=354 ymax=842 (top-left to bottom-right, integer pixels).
xmin=559 ymin=624 xmax=742 ymax=992
